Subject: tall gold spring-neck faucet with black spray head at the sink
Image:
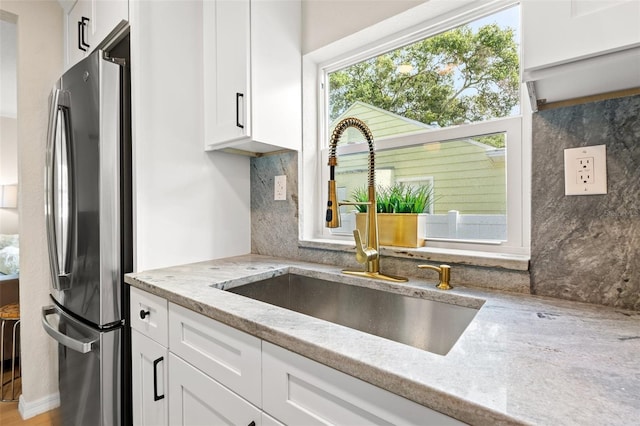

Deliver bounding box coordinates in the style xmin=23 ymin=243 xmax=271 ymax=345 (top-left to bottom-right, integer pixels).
xmin=325 ymin=117 xmax=408 ymax=282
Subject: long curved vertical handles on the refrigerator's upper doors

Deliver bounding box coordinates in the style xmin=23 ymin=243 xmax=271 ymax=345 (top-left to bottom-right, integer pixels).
xmin=45 ymin=89 xmax=74 ymax=290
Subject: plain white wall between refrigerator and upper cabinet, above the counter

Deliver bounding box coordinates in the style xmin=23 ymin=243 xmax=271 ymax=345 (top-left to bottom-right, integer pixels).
xmin=130 ymin=1 xmax=251 ymax=271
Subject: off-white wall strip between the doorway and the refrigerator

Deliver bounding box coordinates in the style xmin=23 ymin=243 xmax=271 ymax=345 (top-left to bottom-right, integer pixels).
xmin=0 ymin=0 xmax=63 ymax=417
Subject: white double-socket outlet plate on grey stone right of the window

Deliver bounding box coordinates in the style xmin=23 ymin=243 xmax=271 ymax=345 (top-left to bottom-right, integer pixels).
xmin=564 ymin=145 xmax=607 ymax=195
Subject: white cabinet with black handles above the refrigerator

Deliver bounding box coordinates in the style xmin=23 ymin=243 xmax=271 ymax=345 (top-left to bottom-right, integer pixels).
xmin=62 ymin=0 xmax=129 ymax=69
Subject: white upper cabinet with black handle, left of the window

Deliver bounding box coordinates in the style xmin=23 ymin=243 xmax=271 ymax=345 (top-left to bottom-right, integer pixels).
xmin=203 ymin=0 xmax=302 ymax=153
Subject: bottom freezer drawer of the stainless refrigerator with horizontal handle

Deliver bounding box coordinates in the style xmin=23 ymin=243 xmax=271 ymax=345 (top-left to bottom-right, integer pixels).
xmin=42 ymin=306 xmax=122 ymax=426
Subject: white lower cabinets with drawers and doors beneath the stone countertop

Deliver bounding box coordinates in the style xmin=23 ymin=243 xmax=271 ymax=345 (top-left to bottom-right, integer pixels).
xmin=131 ymin=289 xmax=462 ymax=426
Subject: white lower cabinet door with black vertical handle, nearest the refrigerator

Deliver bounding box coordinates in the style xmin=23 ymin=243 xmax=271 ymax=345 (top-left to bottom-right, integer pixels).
xmin=131 ymin=330 xmax=169 ymax=426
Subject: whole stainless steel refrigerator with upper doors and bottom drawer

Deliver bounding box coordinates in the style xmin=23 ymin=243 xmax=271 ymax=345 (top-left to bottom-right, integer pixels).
xmin=42 ymin=38 xmax=132 ymax=426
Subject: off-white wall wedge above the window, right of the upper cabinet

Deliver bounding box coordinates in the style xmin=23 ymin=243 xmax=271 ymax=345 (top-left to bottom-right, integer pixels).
xmin=302 ymin=0 xmax=428 ymax=54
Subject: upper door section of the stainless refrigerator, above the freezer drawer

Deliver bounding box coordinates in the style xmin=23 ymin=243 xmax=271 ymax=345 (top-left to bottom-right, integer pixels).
xmin=46 ymin=50 xmax=123 ymax=327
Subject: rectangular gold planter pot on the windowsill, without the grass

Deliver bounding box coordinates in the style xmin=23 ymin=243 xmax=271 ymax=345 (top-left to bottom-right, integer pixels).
xmin=356 ymin=213 xmax=427 ymax=247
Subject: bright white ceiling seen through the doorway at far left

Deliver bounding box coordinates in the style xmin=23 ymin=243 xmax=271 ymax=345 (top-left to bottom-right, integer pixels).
xmin=0 ymin=19 xmax=18 ymax=118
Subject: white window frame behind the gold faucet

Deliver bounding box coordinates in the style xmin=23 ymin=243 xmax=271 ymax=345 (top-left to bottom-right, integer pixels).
xmin=299 ymin=0 xmax=531 ymax=256
